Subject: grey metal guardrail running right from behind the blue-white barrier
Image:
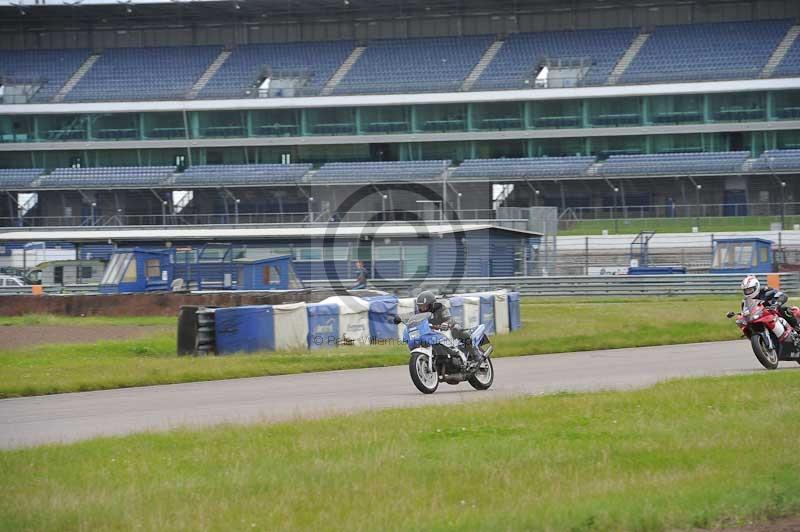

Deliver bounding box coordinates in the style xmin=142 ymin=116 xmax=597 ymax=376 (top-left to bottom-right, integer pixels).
xmin=304 ymin=272 xmax=800 ymax=297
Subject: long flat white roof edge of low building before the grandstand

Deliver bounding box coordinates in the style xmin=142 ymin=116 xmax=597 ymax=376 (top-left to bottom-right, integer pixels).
xmin=0 ymin=222 xmax=541 ymax=242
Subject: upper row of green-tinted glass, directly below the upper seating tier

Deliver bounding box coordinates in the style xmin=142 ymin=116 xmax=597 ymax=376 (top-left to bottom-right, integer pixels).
xmin=0 ymin=91 xmax=800 ymax=142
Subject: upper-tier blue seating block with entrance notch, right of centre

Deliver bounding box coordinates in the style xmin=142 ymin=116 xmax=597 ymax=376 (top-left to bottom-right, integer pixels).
xmin=475 ymin=29 xmax=637 ymax=90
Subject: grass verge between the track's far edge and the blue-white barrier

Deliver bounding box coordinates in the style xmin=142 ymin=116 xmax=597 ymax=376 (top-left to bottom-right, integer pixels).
xmin=0 ymin=298 xmax=739 ymax=397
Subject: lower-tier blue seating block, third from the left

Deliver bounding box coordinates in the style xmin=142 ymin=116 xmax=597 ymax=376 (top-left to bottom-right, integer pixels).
xmin=174 ymin=164 xmax=311 ymax=186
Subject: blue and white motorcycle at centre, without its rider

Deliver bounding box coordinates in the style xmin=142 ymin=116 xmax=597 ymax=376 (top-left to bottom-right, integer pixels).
xmin=398 ymin=312 xmax=494 ymax=394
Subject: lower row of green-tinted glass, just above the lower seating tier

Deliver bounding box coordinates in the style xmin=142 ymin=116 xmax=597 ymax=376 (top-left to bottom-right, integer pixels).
xmin=0 ymin=130 xmax=800 ymax=169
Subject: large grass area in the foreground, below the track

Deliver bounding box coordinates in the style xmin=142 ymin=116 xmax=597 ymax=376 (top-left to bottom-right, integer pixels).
xmin=0 ymin=371 xmax=800 ymax=531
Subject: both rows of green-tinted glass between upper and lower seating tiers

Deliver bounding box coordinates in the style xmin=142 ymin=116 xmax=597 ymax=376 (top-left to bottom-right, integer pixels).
xmin=0 ymin=90 xmax=800 ymax=168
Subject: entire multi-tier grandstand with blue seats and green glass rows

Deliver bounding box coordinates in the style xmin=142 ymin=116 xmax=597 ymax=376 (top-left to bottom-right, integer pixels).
xmin=0 ymin=0 xmax=800 ymax=233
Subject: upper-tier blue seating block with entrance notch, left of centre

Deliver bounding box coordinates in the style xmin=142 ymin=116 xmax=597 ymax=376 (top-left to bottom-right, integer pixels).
xmin=199 ymin=41 xmax=354 ymax=98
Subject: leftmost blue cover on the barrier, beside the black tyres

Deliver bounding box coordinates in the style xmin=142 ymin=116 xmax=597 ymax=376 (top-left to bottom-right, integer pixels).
xmin=215 ymin=305 xmax=275 ymax=354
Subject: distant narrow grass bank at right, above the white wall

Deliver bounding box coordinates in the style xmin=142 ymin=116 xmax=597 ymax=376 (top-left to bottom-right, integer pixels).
xmin=558 ymin=216 xmax=800 ymax=236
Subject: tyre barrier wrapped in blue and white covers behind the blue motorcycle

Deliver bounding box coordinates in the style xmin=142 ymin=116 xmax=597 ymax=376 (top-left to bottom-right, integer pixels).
xmin=178 ymin=290 xmax=522 ymax=355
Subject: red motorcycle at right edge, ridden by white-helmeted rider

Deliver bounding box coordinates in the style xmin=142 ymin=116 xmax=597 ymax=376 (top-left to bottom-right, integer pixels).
xmin=727 ymin=300 xmax=800 ymax=369
